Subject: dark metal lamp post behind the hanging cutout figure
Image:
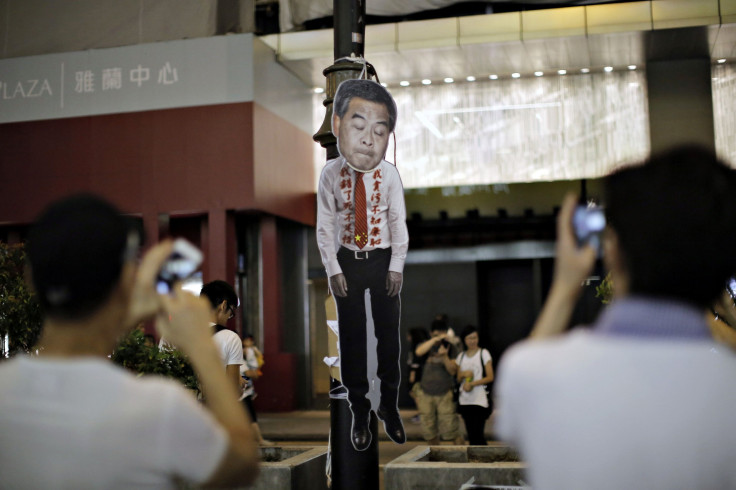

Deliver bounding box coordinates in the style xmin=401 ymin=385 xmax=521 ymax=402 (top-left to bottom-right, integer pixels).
xmin=314 ymin=0 xmax=379 ymax=490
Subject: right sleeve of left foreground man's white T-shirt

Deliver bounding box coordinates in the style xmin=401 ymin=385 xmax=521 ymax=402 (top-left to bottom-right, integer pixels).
xmin=158 ymin=383 xmax=229 ymax=484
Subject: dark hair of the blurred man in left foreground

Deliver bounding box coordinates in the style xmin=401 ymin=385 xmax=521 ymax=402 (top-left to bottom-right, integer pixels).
xmin=27 ymin=194 xmax=140 ymax=320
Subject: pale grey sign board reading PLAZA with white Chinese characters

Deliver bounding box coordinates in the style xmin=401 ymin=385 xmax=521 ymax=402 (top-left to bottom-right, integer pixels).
xmin=0 ymin=34 xmax=253 ymax=123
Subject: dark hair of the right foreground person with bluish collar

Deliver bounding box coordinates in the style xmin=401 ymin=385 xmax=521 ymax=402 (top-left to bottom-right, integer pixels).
xmin=605 ymin=146 xmax=736 ymax=307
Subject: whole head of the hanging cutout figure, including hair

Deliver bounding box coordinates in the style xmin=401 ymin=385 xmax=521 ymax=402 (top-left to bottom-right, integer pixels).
xmin=332 ymin=79 xmax=396 ymax=170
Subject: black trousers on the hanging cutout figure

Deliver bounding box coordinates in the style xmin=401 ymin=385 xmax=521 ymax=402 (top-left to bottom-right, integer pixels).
xmin=335 ymin=247 xmax=401 ymax=417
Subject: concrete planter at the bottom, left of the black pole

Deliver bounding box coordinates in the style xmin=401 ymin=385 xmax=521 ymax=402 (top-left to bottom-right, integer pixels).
xmin=248 ymin=446 xmax=327 ymax=490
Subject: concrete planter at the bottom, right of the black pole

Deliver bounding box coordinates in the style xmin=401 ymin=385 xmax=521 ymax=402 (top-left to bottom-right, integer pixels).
xmin=383 ymin=446 xmax=526 ymax=490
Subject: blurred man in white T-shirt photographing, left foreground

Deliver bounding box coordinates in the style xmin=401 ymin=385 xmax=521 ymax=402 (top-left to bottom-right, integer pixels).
xmin=0 ymin=195 xmax=259 ymax=489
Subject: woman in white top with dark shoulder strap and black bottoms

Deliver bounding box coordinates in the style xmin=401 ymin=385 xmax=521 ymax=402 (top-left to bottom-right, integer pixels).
xmin=455 ymin=325 xmax=493 ymax=446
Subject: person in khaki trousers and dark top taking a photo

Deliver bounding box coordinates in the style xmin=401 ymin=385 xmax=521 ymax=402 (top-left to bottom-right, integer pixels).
xmin=414 ymin=320 xmax=465 ymax=446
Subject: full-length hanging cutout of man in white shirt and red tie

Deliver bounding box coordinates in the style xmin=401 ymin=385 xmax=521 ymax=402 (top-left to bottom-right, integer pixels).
xmin=317 ymin=80 xmax=409 ymax=450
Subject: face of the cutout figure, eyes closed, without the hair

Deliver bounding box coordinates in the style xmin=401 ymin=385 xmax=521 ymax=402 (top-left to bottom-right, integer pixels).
xmin=332 ymin=97 xmax=389 ymax=170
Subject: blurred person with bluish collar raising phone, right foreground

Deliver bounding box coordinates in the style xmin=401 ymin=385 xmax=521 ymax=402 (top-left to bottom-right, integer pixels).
xmin=494 ymin=146 xmax=736 ymax=490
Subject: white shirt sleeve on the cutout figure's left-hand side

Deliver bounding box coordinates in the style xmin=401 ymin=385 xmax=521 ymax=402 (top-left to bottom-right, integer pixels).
xmin=317 ymin=162 xmax=342 ymax=277
